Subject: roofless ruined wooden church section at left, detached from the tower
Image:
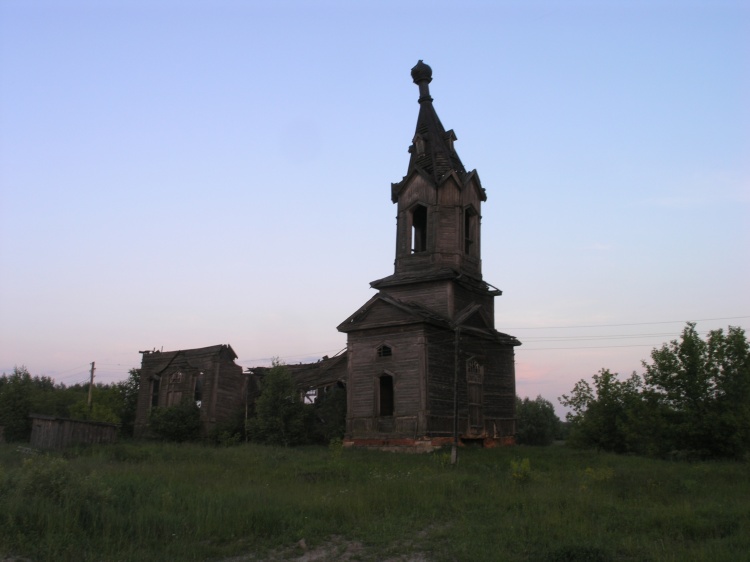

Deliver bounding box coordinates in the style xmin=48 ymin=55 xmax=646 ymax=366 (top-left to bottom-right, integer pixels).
xmin=135 ymin=345 xmax=248 ymax=437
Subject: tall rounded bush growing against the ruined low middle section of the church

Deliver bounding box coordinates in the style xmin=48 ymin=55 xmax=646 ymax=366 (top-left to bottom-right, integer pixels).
xmin=250 ymin=359 xmax=306 ymax=446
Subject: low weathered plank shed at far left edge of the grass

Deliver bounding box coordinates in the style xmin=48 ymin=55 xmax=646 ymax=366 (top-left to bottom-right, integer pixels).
xmin=29 ymin=414 xmax=119 ymax=451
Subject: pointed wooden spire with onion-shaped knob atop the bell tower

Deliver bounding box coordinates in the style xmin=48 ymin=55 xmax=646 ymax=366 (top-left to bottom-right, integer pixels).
xmin=406 ymin=60 xmax=466 ymax=183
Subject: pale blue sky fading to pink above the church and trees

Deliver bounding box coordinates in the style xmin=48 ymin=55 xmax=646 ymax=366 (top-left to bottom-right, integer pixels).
xmin=0 ymin=0 xmax=750 ymax=412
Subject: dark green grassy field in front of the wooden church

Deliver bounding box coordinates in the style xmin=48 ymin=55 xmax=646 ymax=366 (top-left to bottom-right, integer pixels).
xmin=0 ymin=443 xmax=750 ymax=562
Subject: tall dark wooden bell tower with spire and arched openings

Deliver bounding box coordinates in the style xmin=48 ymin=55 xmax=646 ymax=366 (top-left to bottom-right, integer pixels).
xmin=338 ymin=61 xmax=520 ymax=447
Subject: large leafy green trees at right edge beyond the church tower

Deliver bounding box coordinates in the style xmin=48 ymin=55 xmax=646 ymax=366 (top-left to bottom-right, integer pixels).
xmin=559 ymin=323 xmax=750 ymax=459
